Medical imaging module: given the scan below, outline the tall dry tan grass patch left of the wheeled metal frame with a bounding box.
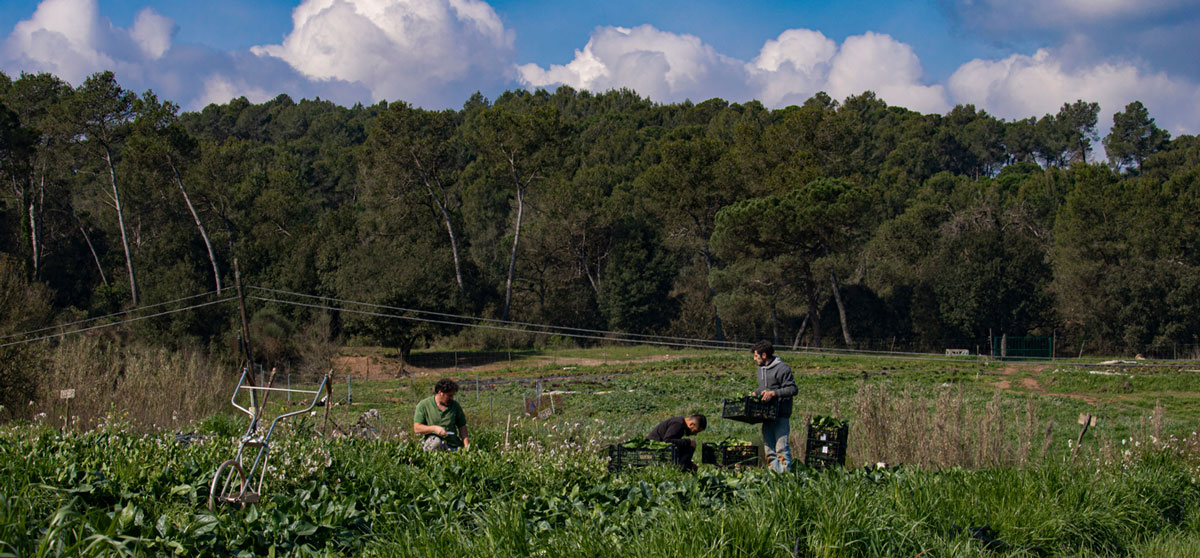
[35,337,236,428]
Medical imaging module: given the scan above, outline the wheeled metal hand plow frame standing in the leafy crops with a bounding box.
[209,367,331,511]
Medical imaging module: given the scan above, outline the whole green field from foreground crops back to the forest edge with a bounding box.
[0,348,1200,557]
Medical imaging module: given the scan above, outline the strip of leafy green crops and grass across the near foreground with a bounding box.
[0,417,1200,557]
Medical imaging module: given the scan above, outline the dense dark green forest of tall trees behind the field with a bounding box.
[0,72,1200,374]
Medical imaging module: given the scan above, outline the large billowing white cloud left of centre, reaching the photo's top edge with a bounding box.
[251,0,514,108]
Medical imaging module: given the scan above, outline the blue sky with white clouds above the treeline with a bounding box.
[0,0,1200,136]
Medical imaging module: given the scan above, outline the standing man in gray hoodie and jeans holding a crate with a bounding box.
[751,340,799,473]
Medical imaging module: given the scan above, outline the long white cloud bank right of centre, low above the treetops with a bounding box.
[518,25,949,112]
